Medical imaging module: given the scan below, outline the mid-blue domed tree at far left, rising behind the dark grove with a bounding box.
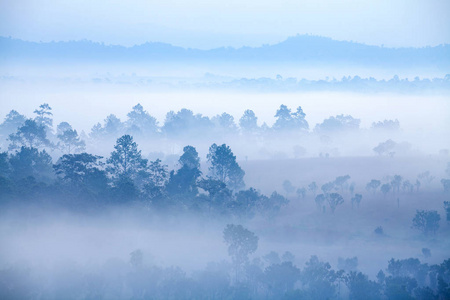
[9,119,52,150]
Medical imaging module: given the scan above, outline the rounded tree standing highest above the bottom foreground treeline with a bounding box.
[223,224,258,281]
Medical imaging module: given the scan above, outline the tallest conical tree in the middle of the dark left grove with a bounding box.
[107,134,147,180]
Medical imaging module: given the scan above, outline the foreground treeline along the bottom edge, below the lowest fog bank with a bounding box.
[0,224,450,300]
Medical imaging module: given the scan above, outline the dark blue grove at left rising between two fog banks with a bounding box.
[0,120,288,218]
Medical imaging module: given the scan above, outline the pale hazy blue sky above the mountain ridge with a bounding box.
[0,0,450,48]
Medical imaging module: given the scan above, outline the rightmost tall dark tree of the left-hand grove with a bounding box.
[207,144,245,190]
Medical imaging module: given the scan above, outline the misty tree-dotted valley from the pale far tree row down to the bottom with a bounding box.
[0,101,450,299]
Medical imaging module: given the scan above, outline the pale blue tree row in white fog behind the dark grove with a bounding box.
[0,104,400,146]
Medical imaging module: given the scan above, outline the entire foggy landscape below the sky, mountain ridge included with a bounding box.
[0,14,450,299]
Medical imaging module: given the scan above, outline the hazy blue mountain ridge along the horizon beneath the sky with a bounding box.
[0,35,450,68]
